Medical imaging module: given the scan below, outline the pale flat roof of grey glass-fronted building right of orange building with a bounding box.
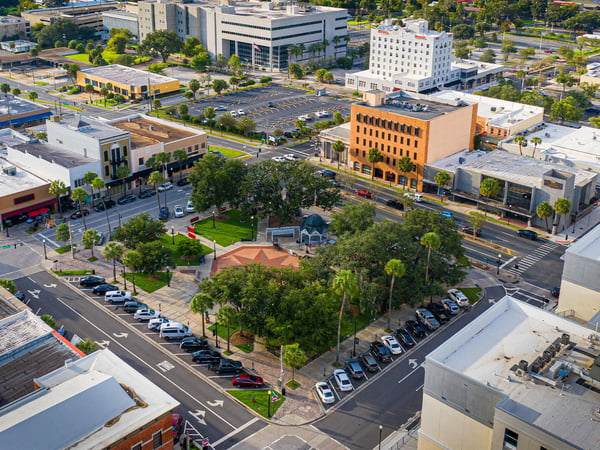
[461,150,596,186]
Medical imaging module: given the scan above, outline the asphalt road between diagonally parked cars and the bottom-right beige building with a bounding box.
[314,286,505,449]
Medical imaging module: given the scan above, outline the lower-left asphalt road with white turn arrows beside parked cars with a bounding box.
[15,271,265,448]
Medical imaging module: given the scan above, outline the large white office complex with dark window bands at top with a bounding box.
[138,0,348,71]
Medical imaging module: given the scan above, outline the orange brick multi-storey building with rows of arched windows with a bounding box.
[349,91,477,191]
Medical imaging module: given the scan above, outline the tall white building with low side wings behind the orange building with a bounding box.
[346,19,503,92]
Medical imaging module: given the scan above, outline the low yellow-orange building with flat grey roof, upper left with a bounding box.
[77,64,179,99]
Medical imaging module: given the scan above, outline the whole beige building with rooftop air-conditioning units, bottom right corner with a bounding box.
[418,296,600,450]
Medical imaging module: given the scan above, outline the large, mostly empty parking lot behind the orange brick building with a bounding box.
[189,85,350,132]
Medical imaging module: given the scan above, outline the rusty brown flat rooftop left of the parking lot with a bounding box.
[110,117,198,148]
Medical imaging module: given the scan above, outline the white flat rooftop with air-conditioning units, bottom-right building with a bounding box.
[425,296,600,449]
